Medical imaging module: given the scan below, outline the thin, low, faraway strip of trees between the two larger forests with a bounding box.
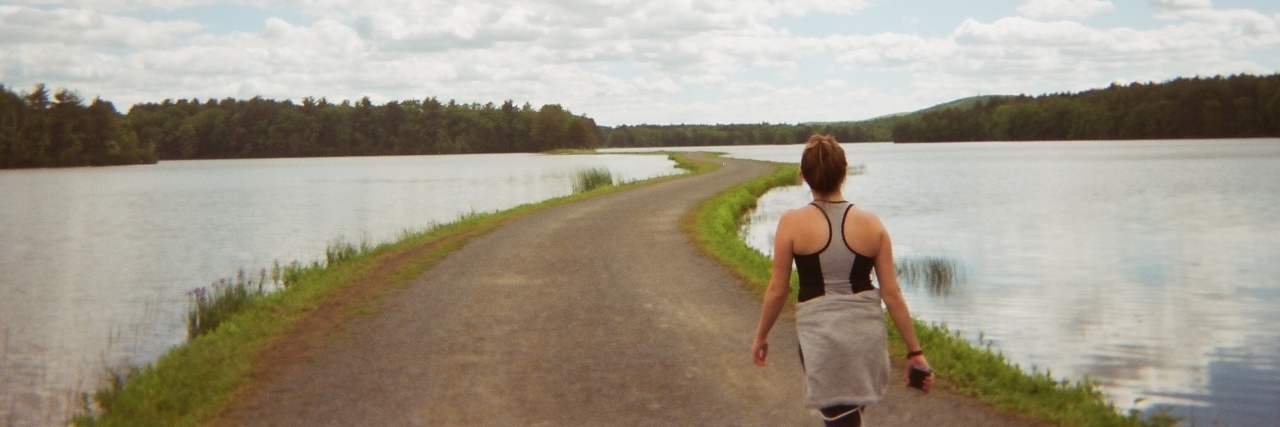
[602,121,876,147]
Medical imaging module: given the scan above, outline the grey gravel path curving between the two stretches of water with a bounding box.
[212,155,1025,427]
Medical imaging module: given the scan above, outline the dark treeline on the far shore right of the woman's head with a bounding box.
[892,74,1280,142]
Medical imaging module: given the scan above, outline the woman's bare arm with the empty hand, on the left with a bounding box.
[751,212,794,366]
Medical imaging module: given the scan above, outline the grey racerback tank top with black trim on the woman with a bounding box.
[795,201,876,302]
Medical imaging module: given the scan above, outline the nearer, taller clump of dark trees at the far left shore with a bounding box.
[0,84,156,169]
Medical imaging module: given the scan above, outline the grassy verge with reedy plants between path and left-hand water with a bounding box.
[73,153,708,426]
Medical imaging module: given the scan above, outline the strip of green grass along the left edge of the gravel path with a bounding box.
[70,153,705,426]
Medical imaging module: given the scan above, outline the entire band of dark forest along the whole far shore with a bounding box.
[0,74,1280,167]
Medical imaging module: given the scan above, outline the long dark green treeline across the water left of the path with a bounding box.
[0,84,600,167]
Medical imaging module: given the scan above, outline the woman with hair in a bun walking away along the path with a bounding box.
[751,136,933,427]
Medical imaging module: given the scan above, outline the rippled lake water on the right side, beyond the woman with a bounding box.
[660,139,1280,426]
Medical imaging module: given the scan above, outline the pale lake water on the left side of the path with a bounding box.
[0,155,678,426]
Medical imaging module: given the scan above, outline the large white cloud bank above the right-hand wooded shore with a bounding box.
[827,10,1280,112]
